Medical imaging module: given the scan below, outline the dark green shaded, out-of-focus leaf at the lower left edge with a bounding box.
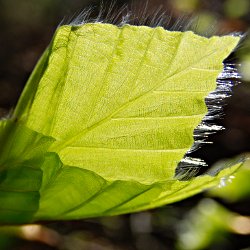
[0,121,54,224]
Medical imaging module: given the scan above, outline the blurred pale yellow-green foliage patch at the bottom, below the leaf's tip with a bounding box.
[177,199,235,250]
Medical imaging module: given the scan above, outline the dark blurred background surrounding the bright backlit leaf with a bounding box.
[0,0,250,250]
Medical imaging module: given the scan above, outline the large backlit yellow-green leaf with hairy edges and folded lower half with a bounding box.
[0,23,240,221]
